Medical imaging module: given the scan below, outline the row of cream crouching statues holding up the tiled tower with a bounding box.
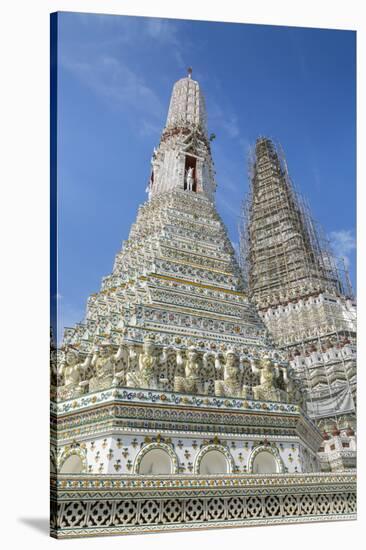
[57,336,301,408]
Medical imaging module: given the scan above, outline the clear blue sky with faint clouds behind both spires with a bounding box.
[58,13,356,342]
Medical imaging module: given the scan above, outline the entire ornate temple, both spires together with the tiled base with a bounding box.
[51,15,356,538]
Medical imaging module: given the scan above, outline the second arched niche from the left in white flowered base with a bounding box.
[134,443,178,475]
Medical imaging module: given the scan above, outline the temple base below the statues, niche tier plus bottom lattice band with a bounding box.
[51,388,356,538]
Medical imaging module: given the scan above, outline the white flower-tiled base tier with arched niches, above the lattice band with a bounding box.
[51,388,323,476]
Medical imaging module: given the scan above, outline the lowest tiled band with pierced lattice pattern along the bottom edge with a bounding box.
[51,473,356,538]
